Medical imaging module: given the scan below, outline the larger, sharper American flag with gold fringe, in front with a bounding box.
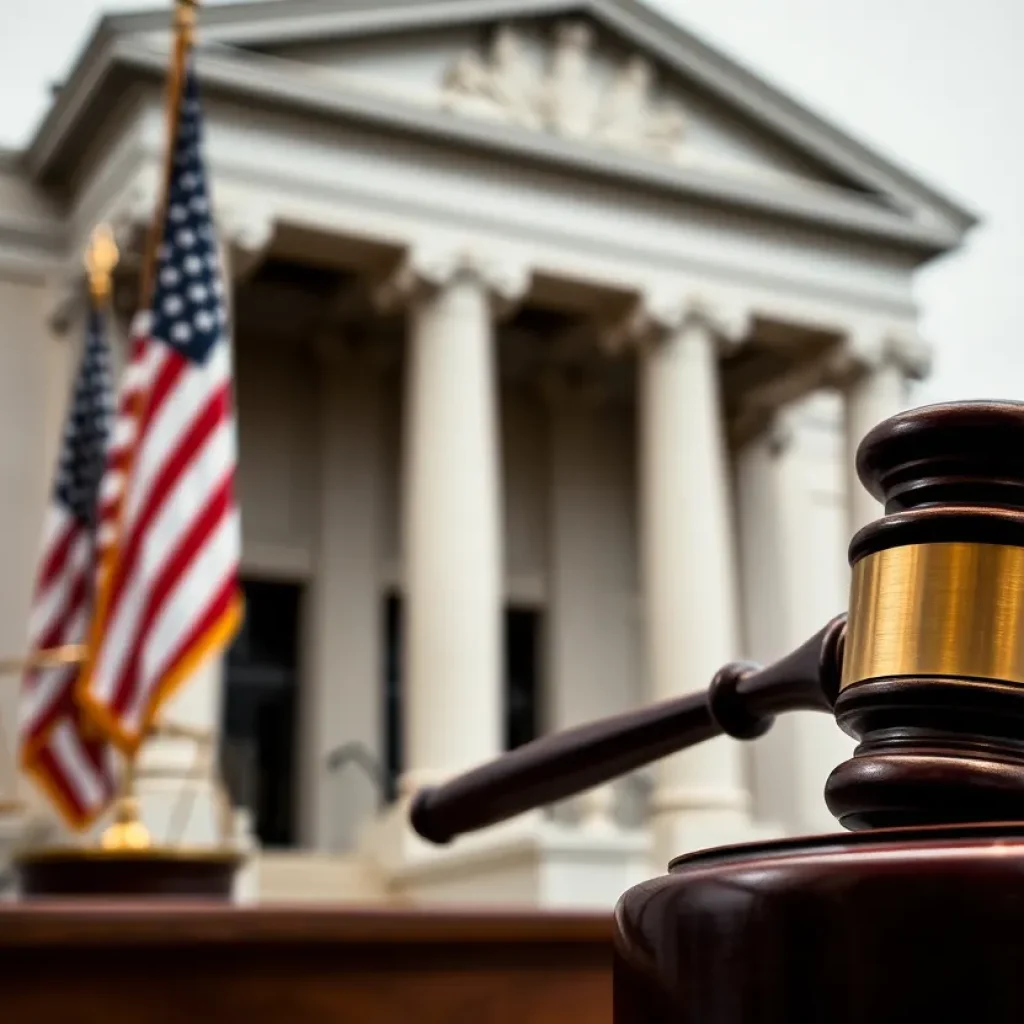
[79,62,242,752]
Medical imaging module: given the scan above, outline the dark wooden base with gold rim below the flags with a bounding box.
[13,847,244,901]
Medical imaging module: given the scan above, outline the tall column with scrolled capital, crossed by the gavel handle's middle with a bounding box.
[610,299,751,864]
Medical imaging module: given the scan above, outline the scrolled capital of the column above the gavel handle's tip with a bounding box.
[373,246,532,315]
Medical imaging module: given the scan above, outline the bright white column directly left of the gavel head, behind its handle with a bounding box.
[736,391,853,836]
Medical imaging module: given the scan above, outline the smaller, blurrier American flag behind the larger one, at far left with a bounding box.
[19,308,116,828]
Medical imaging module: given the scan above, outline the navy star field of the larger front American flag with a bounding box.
[150,62,227,364]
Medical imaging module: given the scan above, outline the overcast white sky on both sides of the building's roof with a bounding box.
[0,0,1024,400]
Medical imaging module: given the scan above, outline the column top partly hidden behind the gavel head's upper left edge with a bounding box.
[845,332,930,537]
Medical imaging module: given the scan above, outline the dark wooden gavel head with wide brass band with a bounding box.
[825,402,1024,829]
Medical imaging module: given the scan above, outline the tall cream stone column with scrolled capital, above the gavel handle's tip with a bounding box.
[378,252,527,793]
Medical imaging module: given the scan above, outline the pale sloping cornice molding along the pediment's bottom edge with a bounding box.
[27,32,962,257]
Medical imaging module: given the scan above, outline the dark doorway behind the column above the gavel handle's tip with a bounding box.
[383,594,544,801]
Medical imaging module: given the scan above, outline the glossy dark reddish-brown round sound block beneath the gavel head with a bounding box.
[614,823,1024,1024]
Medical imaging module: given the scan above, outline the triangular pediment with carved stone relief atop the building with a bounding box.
[30,0,975,252]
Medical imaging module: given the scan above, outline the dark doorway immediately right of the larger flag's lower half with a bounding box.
[220,581,301,847]
